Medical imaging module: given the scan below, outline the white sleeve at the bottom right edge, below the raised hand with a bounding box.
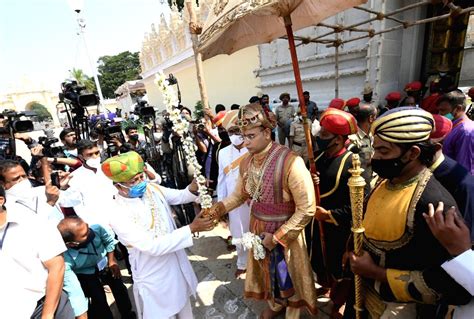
[441,249,474,319]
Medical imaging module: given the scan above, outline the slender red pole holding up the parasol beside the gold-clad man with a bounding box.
[283,15,329,283]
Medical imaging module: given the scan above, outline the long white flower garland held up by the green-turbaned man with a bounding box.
[155,72,212,209]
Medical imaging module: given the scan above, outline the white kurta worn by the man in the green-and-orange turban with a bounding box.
[110,184,197,319]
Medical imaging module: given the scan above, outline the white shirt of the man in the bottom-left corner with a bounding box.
[0,205,66,319]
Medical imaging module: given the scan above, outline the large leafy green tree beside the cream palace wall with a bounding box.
[98,51,140,98]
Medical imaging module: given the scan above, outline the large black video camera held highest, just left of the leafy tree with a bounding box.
[59,81,99,114]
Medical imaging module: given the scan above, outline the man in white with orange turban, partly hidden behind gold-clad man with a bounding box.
[217,110,250,278]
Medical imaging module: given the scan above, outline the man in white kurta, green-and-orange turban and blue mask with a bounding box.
[102,152,212,319]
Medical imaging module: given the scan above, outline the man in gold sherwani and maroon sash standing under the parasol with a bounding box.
[209,104,317,318]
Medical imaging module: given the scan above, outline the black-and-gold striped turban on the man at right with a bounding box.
[371,107,434,144]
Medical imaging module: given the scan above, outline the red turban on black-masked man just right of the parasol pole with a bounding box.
[320,108,358,135]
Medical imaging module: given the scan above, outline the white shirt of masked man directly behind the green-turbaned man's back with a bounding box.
[68,166,117,229]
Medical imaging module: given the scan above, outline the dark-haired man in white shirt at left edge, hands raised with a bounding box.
[0,160,71,224]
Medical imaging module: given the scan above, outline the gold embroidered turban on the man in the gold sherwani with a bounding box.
[237,103,276,130]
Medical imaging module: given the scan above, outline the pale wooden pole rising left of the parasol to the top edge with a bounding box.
[185,0,209,114]
